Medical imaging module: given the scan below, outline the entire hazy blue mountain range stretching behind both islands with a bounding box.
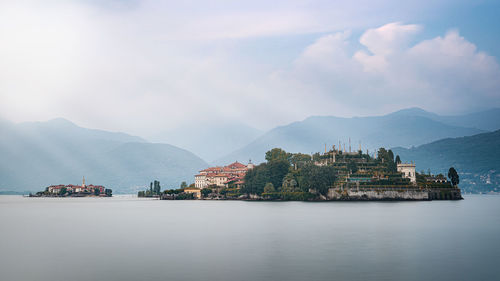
[0,108,500,192]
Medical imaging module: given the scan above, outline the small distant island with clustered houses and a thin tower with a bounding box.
[29,177,113,197]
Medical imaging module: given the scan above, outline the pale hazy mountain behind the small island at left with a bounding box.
[0,119,208,192]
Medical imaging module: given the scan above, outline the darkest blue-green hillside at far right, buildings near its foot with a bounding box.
[392,130,500,192]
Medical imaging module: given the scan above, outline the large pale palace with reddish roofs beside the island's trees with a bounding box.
[194,161,254,189]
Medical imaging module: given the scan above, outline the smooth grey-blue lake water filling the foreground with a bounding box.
[0,196,500,281]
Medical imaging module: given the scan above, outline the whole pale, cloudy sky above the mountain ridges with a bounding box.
[0,0,500,136]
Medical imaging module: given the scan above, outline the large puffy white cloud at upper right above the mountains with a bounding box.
[272,22,500,114]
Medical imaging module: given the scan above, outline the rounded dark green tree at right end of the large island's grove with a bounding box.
[299,164,336,195]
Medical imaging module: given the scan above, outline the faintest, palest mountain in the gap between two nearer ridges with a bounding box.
[149,120,262,162]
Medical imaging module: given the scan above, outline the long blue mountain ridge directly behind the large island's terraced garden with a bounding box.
[216,109,484,163]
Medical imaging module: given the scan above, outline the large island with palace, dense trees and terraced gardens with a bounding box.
[157,144,463,201]
